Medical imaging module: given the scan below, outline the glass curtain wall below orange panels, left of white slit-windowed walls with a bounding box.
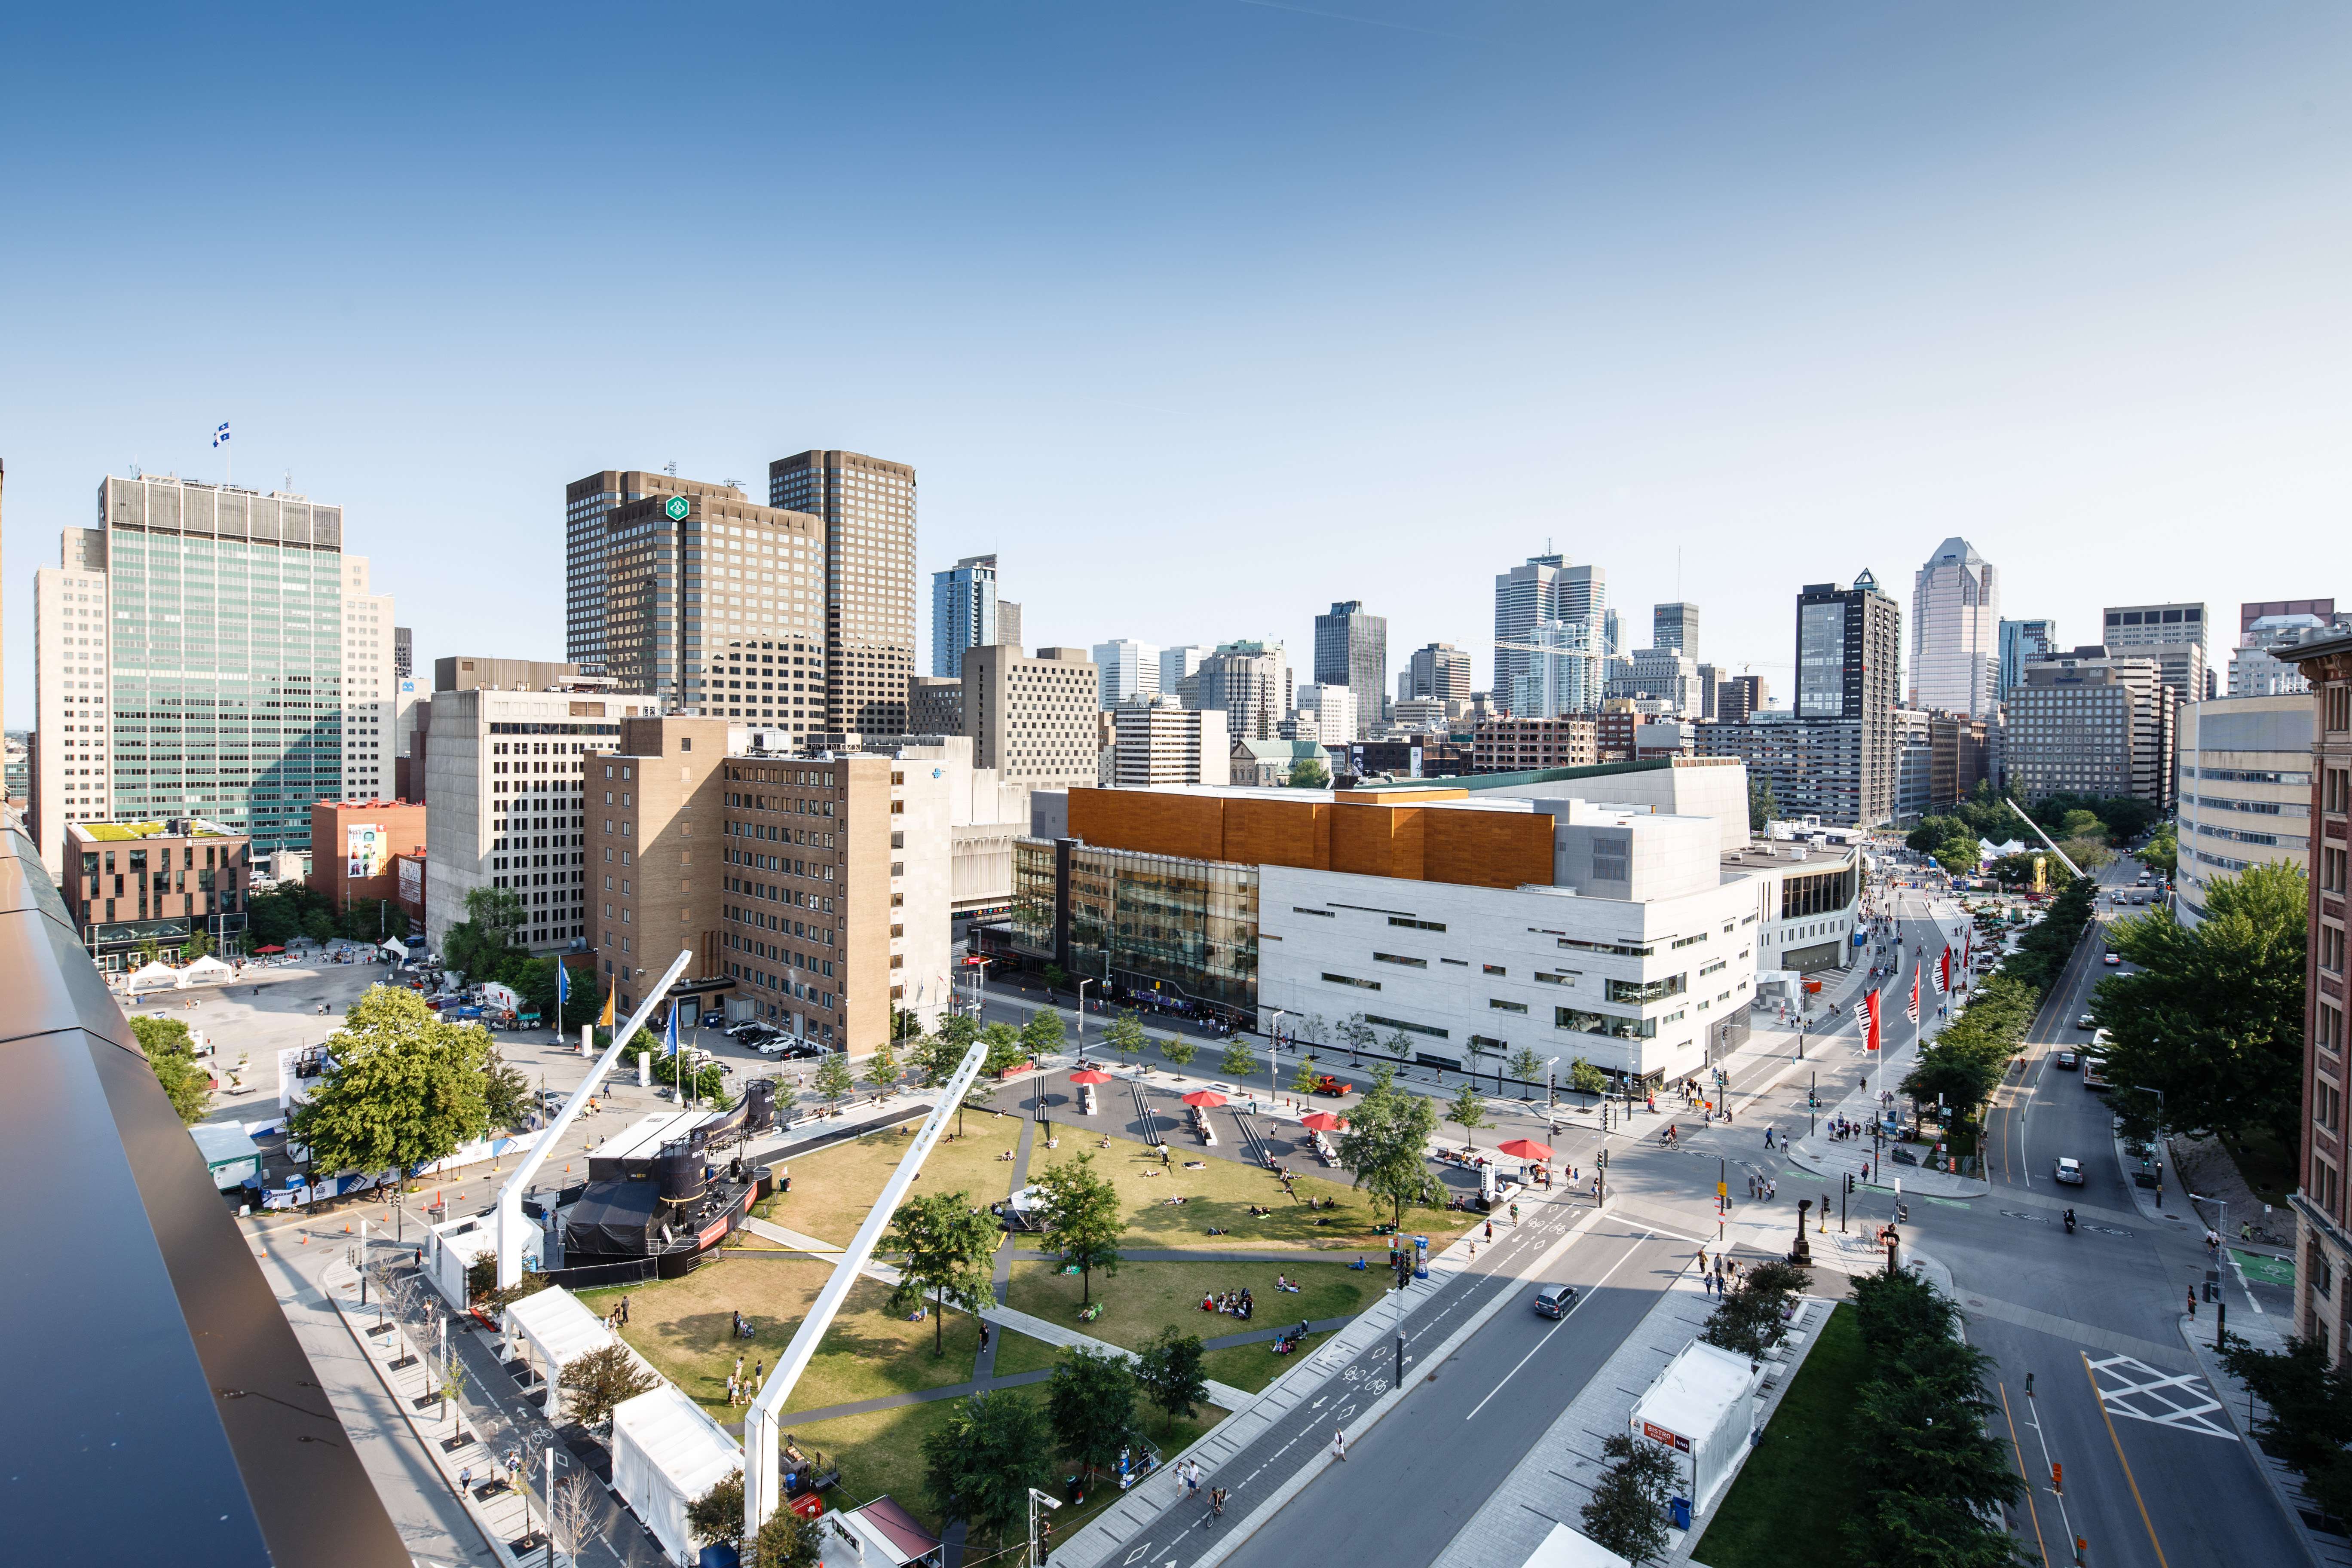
[1014,839,1259,1016]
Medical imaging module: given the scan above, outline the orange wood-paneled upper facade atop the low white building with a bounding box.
[1070,790,1553,888]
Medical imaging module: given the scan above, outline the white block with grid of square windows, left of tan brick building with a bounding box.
[426,686,661,952]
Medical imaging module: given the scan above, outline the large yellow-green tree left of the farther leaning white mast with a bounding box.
[287,985,489,1173]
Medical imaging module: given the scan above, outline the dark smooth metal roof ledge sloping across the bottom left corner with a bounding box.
[0,827,409,1568]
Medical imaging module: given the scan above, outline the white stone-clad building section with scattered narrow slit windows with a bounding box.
[1259,804,1759,1084]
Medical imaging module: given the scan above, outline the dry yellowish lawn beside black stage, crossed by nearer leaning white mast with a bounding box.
[581,1253,981,1422]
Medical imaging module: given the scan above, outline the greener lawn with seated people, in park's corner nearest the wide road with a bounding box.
[997,1262,1387,1363]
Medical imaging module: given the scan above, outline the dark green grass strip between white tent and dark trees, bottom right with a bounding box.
[1691,1305,1868,1568]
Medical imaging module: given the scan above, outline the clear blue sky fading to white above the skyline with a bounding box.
[0,0,2352,729]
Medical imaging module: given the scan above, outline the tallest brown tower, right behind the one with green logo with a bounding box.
[767,451,917,736]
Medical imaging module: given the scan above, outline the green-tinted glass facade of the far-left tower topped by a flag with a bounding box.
[99,480,343,856]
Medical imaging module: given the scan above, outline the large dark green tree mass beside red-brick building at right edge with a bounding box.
[2091,865,2307,1147]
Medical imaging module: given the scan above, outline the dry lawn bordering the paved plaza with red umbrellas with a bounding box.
[1030,1128,1479,1250]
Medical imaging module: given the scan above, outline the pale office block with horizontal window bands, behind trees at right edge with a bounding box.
[2176,691,2305,926]
